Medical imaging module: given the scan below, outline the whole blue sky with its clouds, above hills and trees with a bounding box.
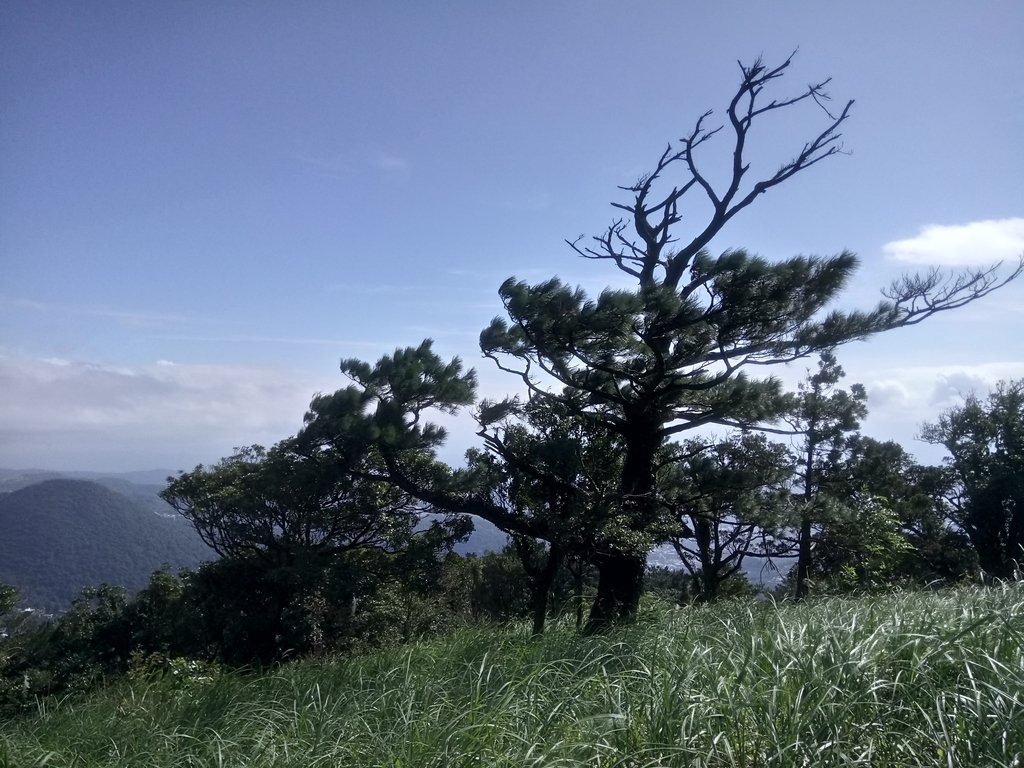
[0,0,1024,471]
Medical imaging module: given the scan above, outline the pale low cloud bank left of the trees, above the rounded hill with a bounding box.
[0,357,344,471]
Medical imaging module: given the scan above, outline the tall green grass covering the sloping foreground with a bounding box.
[0,585,1024,768]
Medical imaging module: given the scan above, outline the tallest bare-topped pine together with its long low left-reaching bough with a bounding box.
[305,56,1024,630]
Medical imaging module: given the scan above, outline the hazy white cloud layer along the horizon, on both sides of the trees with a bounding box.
[0,356,1024,471]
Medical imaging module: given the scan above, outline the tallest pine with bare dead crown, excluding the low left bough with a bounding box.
[480,56,1024,629]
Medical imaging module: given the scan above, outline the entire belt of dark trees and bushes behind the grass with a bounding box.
[0,54,1024,720]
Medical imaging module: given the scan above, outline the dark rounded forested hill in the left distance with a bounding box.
[0,475,216,612]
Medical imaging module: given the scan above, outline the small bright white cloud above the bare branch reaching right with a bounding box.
[882,218,1024,266]
